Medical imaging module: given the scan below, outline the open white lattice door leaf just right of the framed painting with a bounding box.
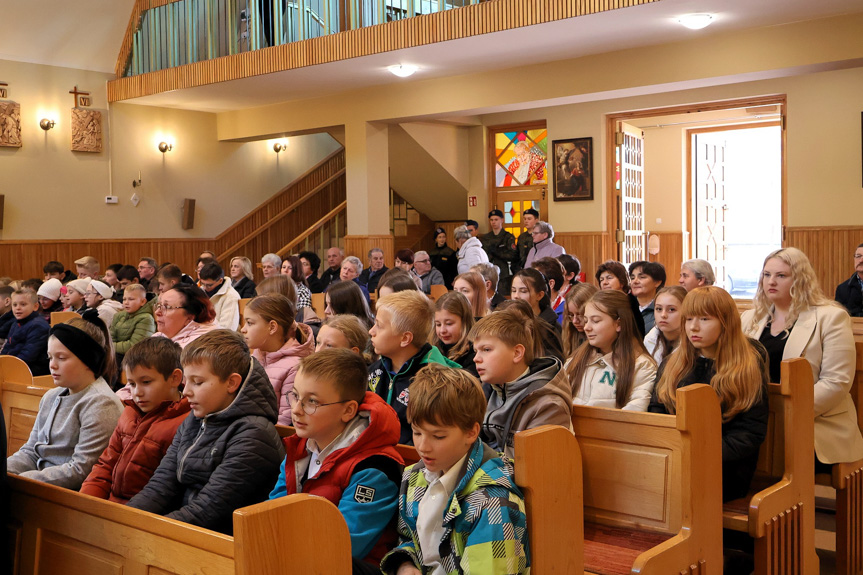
[615,122,647,266]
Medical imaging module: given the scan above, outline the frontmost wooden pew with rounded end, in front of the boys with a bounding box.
[9,475,351,575]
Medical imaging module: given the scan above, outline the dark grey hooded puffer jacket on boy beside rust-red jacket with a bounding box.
[128,358,285,534]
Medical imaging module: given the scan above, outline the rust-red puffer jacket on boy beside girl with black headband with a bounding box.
[81,398,189,503]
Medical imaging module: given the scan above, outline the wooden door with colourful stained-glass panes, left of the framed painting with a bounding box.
[489,122,548,226]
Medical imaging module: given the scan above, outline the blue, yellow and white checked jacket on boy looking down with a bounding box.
[381,440,530,575]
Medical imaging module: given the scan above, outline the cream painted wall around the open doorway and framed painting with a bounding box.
[483,68,863,236]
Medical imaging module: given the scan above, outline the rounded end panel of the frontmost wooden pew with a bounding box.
[234,493,351,575]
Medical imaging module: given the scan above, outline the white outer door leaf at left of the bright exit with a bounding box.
[693,133,728,287]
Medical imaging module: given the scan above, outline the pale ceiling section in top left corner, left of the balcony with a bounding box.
[0,0,135,73]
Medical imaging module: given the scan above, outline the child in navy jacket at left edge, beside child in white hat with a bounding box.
[2,289,51,379]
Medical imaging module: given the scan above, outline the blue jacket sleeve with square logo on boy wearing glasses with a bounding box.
[339,469,399,559]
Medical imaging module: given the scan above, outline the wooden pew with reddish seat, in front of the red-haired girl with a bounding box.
[572,385,722,575]
